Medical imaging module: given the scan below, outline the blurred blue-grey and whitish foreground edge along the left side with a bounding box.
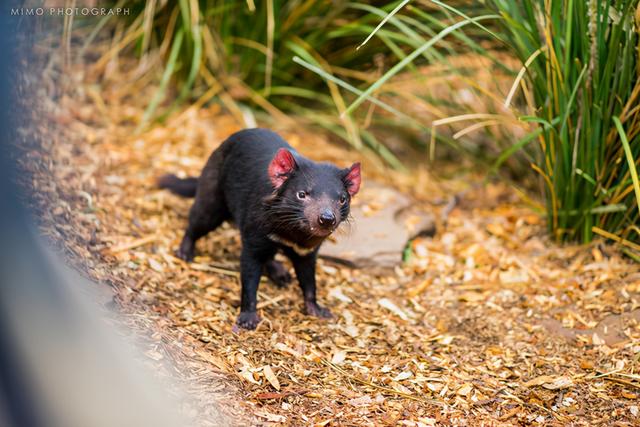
[0,1,194,427]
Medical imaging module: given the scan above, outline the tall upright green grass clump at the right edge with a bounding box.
[490,0,640,247]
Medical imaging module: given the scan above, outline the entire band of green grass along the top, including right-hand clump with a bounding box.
[83,0,640,250]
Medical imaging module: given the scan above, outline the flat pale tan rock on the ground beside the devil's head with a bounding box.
[320,183,435,268]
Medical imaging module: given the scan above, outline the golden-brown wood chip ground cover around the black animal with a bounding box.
[13,49,640,426]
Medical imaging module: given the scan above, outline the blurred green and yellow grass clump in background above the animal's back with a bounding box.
[83,0,438,169]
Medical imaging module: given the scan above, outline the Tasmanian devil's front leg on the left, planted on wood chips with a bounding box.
[236,245,262,329]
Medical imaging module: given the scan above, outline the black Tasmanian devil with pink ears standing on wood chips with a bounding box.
[158,129,360,329]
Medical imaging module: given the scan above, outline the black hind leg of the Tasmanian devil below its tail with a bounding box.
[176,150,229,261]
